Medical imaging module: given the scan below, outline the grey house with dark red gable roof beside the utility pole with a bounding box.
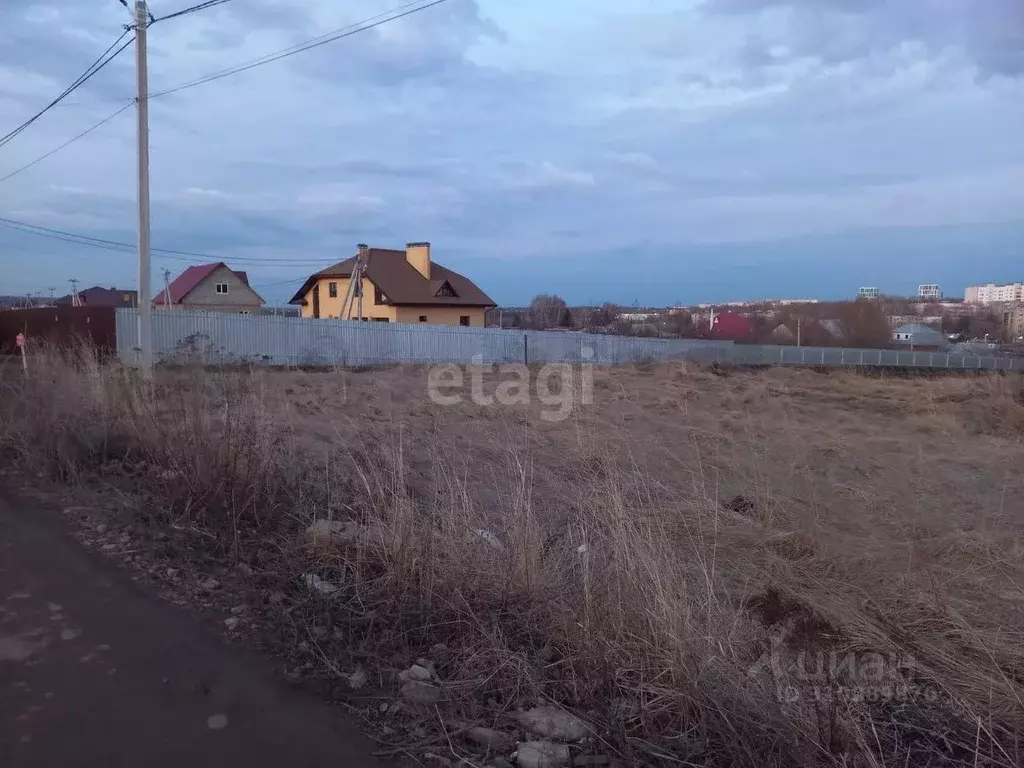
[153,261,265,314]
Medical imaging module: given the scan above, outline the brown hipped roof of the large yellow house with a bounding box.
[289,248,498,306]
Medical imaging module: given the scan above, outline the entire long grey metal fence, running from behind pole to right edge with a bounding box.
[117,309,1024,371]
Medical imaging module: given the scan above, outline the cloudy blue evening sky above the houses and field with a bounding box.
[0,0,1024,305]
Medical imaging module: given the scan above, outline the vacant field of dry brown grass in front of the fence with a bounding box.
[0,358,1024,766]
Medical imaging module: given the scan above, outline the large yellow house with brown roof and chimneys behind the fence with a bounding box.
[289,243,497,328]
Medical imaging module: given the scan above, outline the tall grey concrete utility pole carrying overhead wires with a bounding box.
[135,0,153,376]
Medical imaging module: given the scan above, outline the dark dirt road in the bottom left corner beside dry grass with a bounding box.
[0,492,382,768]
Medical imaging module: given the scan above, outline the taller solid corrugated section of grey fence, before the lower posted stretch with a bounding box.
[117,309,729,367]
